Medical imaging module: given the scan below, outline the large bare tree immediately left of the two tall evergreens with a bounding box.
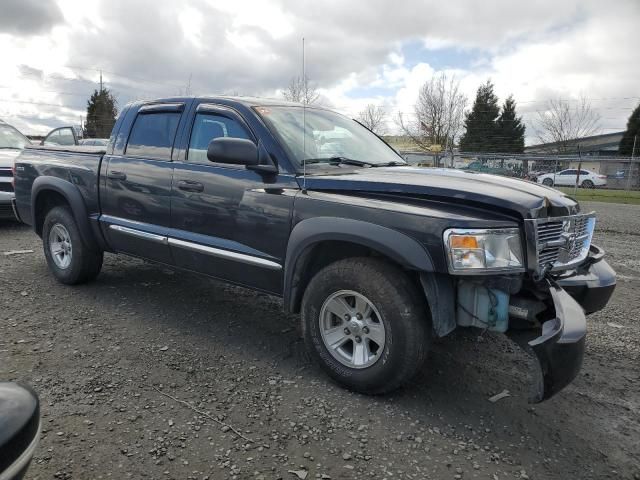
[398,72,467,161]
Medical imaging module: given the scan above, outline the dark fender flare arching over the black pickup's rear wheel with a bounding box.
[31,176,100,250]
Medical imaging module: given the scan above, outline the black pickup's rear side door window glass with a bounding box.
[125,112,180,160]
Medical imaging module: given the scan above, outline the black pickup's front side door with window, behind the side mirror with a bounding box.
[169,105,297,293]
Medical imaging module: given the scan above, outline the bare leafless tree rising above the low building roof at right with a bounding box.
[535,97,600,152]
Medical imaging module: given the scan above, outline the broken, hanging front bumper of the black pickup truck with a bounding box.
[509,246,616,403]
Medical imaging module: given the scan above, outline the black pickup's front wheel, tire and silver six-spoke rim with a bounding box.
[302,258,431,394]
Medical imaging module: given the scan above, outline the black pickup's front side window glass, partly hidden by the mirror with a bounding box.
[187,113,251,163]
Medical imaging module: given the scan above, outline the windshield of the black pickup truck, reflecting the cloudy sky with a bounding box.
[256,106,406,167]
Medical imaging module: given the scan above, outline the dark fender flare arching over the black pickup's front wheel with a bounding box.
[283,217,434,312]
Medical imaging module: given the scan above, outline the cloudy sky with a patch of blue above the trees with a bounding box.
[0,0,640,143]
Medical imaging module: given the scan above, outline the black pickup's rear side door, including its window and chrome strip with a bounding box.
[100,103,184,263]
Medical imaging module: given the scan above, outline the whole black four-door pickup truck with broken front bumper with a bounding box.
[15,97,616,401]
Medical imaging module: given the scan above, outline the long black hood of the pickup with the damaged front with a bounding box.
[306,167,580,218]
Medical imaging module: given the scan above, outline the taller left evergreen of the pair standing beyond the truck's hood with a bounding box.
[460,80,500,152]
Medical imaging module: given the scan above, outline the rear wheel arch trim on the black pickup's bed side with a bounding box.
[31,176,100,250]
